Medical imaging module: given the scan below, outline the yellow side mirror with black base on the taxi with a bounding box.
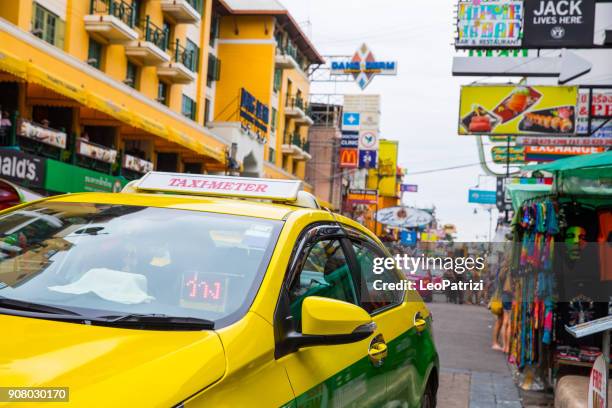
[287,296,376,349]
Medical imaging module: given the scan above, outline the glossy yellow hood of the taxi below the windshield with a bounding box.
[0,315,225,407]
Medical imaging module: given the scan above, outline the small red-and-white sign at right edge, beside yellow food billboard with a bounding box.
[576,89,612,138]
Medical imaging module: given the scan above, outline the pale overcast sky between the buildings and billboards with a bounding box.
[281,0,504,241]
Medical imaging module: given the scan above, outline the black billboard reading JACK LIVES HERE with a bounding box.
[523,0,595,48]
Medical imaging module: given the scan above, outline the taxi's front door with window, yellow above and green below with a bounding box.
[274,225,387,407]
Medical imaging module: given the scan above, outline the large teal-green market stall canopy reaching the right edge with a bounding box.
[522,152,612,196]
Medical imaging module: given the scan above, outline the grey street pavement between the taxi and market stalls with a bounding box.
[427,299,522,408]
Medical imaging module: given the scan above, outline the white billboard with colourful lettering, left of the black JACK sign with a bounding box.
[455,0,523,48]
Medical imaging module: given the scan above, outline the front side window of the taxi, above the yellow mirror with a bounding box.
[289,240,357,327]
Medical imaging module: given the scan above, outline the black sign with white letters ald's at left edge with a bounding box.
[0,149,46,187]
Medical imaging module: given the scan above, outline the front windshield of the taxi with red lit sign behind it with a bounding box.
[0,201,282,327]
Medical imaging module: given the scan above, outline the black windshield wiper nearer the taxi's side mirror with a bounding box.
[92,313,215,330]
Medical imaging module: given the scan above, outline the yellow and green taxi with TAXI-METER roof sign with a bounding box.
[0,172,438,408]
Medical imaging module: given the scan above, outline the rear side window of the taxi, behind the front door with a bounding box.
[353,242,403,314]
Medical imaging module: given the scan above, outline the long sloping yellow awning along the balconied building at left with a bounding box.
[0,28,227,163]
